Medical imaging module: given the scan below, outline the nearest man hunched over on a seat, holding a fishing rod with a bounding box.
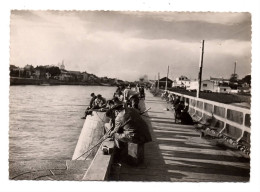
[107,105,152,164]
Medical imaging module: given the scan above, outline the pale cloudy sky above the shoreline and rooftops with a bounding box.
[10,11,251,81]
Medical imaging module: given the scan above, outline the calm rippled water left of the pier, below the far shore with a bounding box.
[9,86,115,160]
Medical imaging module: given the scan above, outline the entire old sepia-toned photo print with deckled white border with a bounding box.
[3,1,259,192]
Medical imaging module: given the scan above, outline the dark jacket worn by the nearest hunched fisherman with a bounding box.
[114,108,152,143]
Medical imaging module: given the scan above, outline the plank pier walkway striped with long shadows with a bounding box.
[110,92,250,182]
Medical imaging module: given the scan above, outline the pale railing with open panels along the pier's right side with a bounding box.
[170,92,251,144]
